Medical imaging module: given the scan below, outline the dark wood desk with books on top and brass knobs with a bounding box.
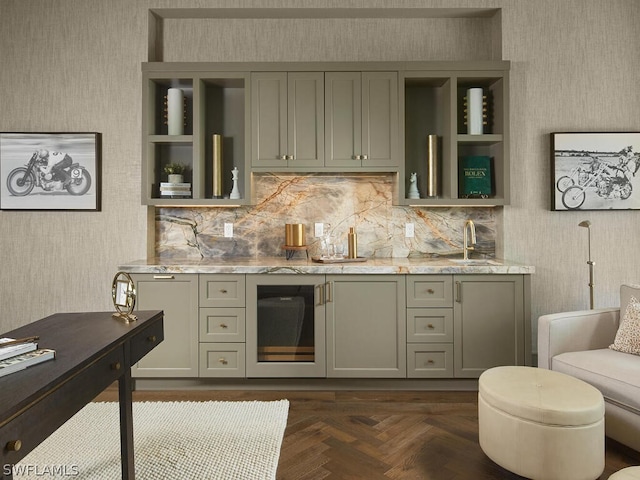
[0,311,164,480]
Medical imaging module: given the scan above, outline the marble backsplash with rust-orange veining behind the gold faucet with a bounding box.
[155,174,496,258]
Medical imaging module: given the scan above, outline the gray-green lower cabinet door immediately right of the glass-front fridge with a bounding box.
[326,275,406,378]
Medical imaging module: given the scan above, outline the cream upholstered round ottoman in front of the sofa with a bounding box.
[478,367,604,480]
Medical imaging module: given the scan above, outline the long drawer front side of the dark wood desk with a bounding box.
[0,345,129,464]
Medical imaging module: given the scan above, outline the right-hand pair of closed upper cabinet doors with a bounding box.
[325,72,399,168]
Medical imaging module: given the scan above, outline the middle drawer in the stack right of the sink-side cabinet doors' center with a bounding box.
[407,308,453,343]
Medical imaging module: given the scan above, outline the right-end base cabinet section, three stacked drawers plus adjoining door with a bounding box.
[406,274,531,378]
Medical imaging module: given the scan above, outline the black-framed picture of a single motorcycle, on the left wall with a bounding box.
[0,132,102,211]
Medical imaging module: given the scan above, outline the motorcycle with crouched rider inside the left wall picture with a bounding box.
[7,152,91,197]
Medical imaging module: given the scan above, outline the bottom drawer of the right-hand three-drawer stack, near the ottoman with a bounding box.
[407,343,453,378]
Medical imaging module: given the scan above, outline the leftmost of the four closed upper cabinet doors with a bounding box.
[251,72,287,167]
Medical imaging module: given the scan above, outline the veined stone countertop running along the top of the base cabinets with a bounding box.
[118,252,535,275]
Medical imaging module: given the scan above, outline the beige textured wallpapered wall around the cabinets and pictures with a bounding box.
[0,0,640,352]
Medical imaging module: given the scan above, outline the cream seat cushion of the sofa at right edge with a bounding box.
[551,348,640,415]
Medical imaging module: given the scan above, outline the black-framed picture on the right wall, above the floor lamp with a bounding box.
[551,132,640,211]
